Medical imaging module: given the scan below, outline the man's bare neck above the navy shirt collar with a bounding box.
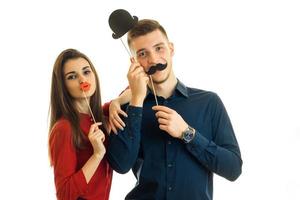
[151,73,177,99]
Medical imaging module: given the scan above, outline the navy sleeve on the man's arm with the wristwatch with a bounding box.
[186,94,242,181]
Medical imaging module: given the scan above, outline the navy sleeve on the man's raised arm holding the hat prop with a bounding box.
[106,106,143,174]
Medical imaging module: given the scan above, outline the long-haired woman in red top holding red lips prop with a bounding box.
[49,49,115,200]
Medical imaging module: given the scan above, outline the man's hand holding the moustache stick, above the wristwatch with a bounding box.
[152,106,188,138]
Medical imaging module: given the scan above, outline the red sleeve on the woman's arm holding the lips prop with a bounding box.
[50,122,87,200]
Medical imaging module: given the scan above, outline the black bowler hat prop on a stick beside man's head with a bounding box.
[108,9,138,39]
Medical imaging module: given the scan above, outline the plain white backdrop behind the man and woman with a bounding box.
[0,0,300,200]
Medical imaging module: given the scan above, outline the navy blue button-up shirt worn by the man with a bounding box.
[107,81,242,200]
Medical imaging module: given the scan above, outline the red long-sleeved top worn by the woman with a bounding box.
[49,111,112,200]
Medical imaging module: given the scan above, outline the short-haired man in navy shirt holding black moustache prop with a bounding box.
[107,20,242,200]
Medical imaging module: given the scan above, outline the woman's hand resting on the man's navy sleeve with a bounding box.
[109,98,127,134]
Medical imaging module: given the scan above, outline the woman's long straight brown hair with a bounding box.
[49,49,106,163]
